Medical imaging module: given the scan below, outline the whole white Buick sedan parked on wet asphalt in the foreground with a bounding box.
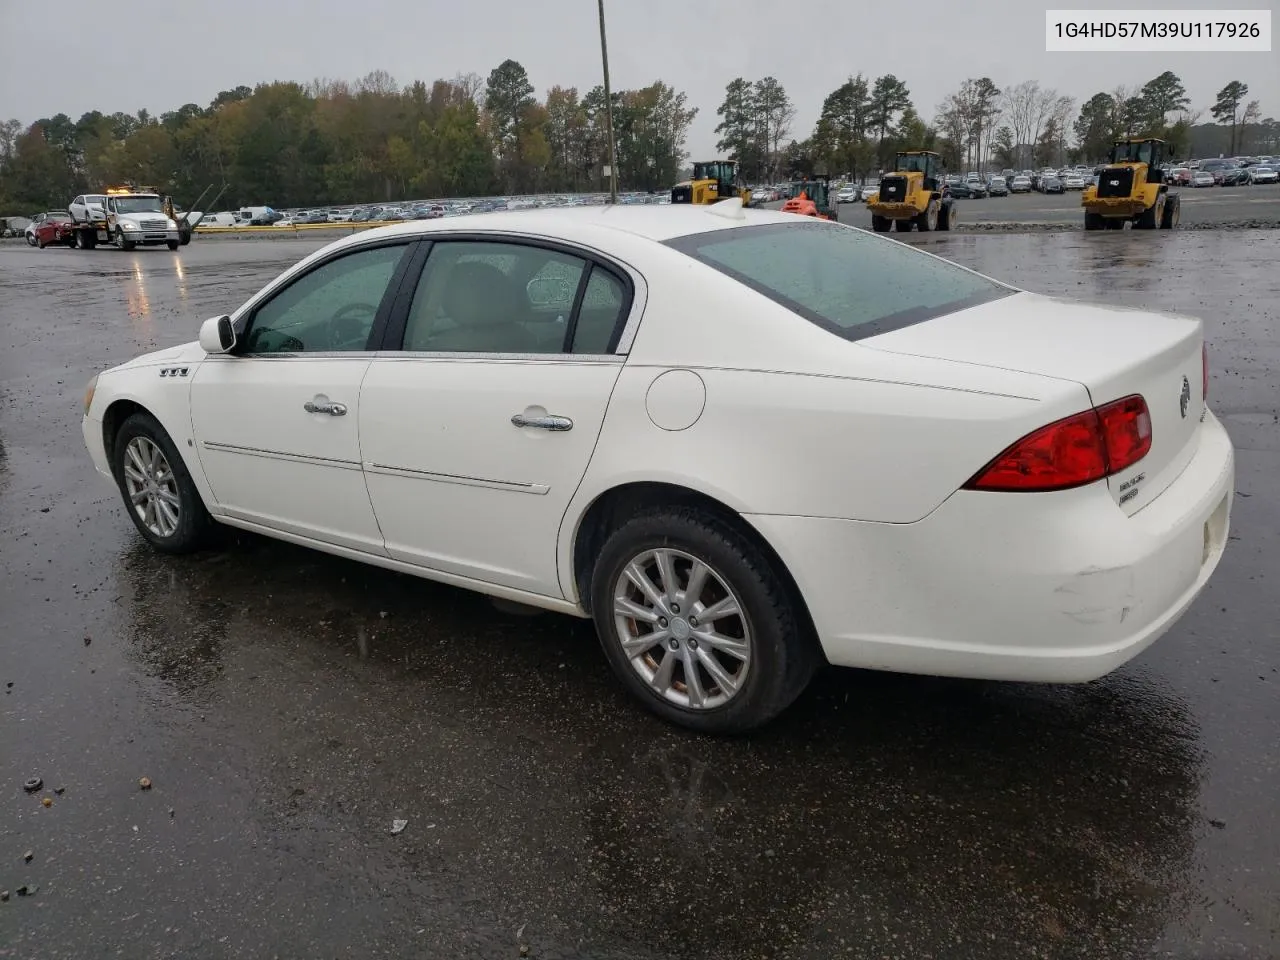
[83,200,1234,732]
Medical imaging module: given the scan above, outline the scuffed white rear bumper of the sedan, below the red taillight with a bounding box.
[748,413,1235,682]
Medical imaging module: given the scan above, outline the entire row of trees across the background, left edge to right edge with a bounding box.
[0,60,1280,215]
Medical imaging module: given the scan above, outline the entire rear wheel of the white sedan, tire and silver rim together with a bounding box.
[591,507,820,733]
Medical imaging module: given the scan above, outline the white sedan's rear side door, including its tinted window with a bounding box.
[360,239,630,598]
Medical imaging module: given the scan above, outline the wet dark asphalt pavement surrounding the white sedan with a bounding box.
[0,232,1280,960]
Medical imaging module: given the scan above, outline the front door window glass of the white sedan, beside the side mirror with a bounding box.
[244,244,408,353]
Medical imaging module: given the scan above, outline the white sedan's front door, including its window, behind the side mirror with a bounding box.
[191,242,412,554]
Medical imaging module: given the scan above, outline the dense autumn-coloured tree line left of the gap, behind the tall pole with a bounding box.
[0,60,696,215]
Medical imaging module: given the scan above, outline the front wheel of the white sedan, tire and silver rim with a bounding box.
[111,413,214,553]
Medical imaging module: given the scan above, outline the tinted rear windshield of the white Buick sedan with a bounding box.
[667,218,1016,340]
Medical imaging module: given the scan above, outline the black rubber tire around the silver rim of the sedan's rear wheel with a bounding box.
[590,507,822,733]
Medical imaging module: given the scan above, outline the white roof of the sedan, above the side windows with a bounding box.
[320,204,796,253]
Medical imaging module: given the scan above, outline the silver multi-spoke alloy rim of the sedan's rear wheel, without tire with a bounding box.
[613,548,751,710]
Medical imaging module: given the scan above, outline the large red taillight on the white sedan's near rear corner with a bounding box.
[964,394,1151,493]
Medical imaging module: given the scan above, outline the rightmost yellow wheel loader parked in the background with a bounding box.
[1080,137,1183,230]
